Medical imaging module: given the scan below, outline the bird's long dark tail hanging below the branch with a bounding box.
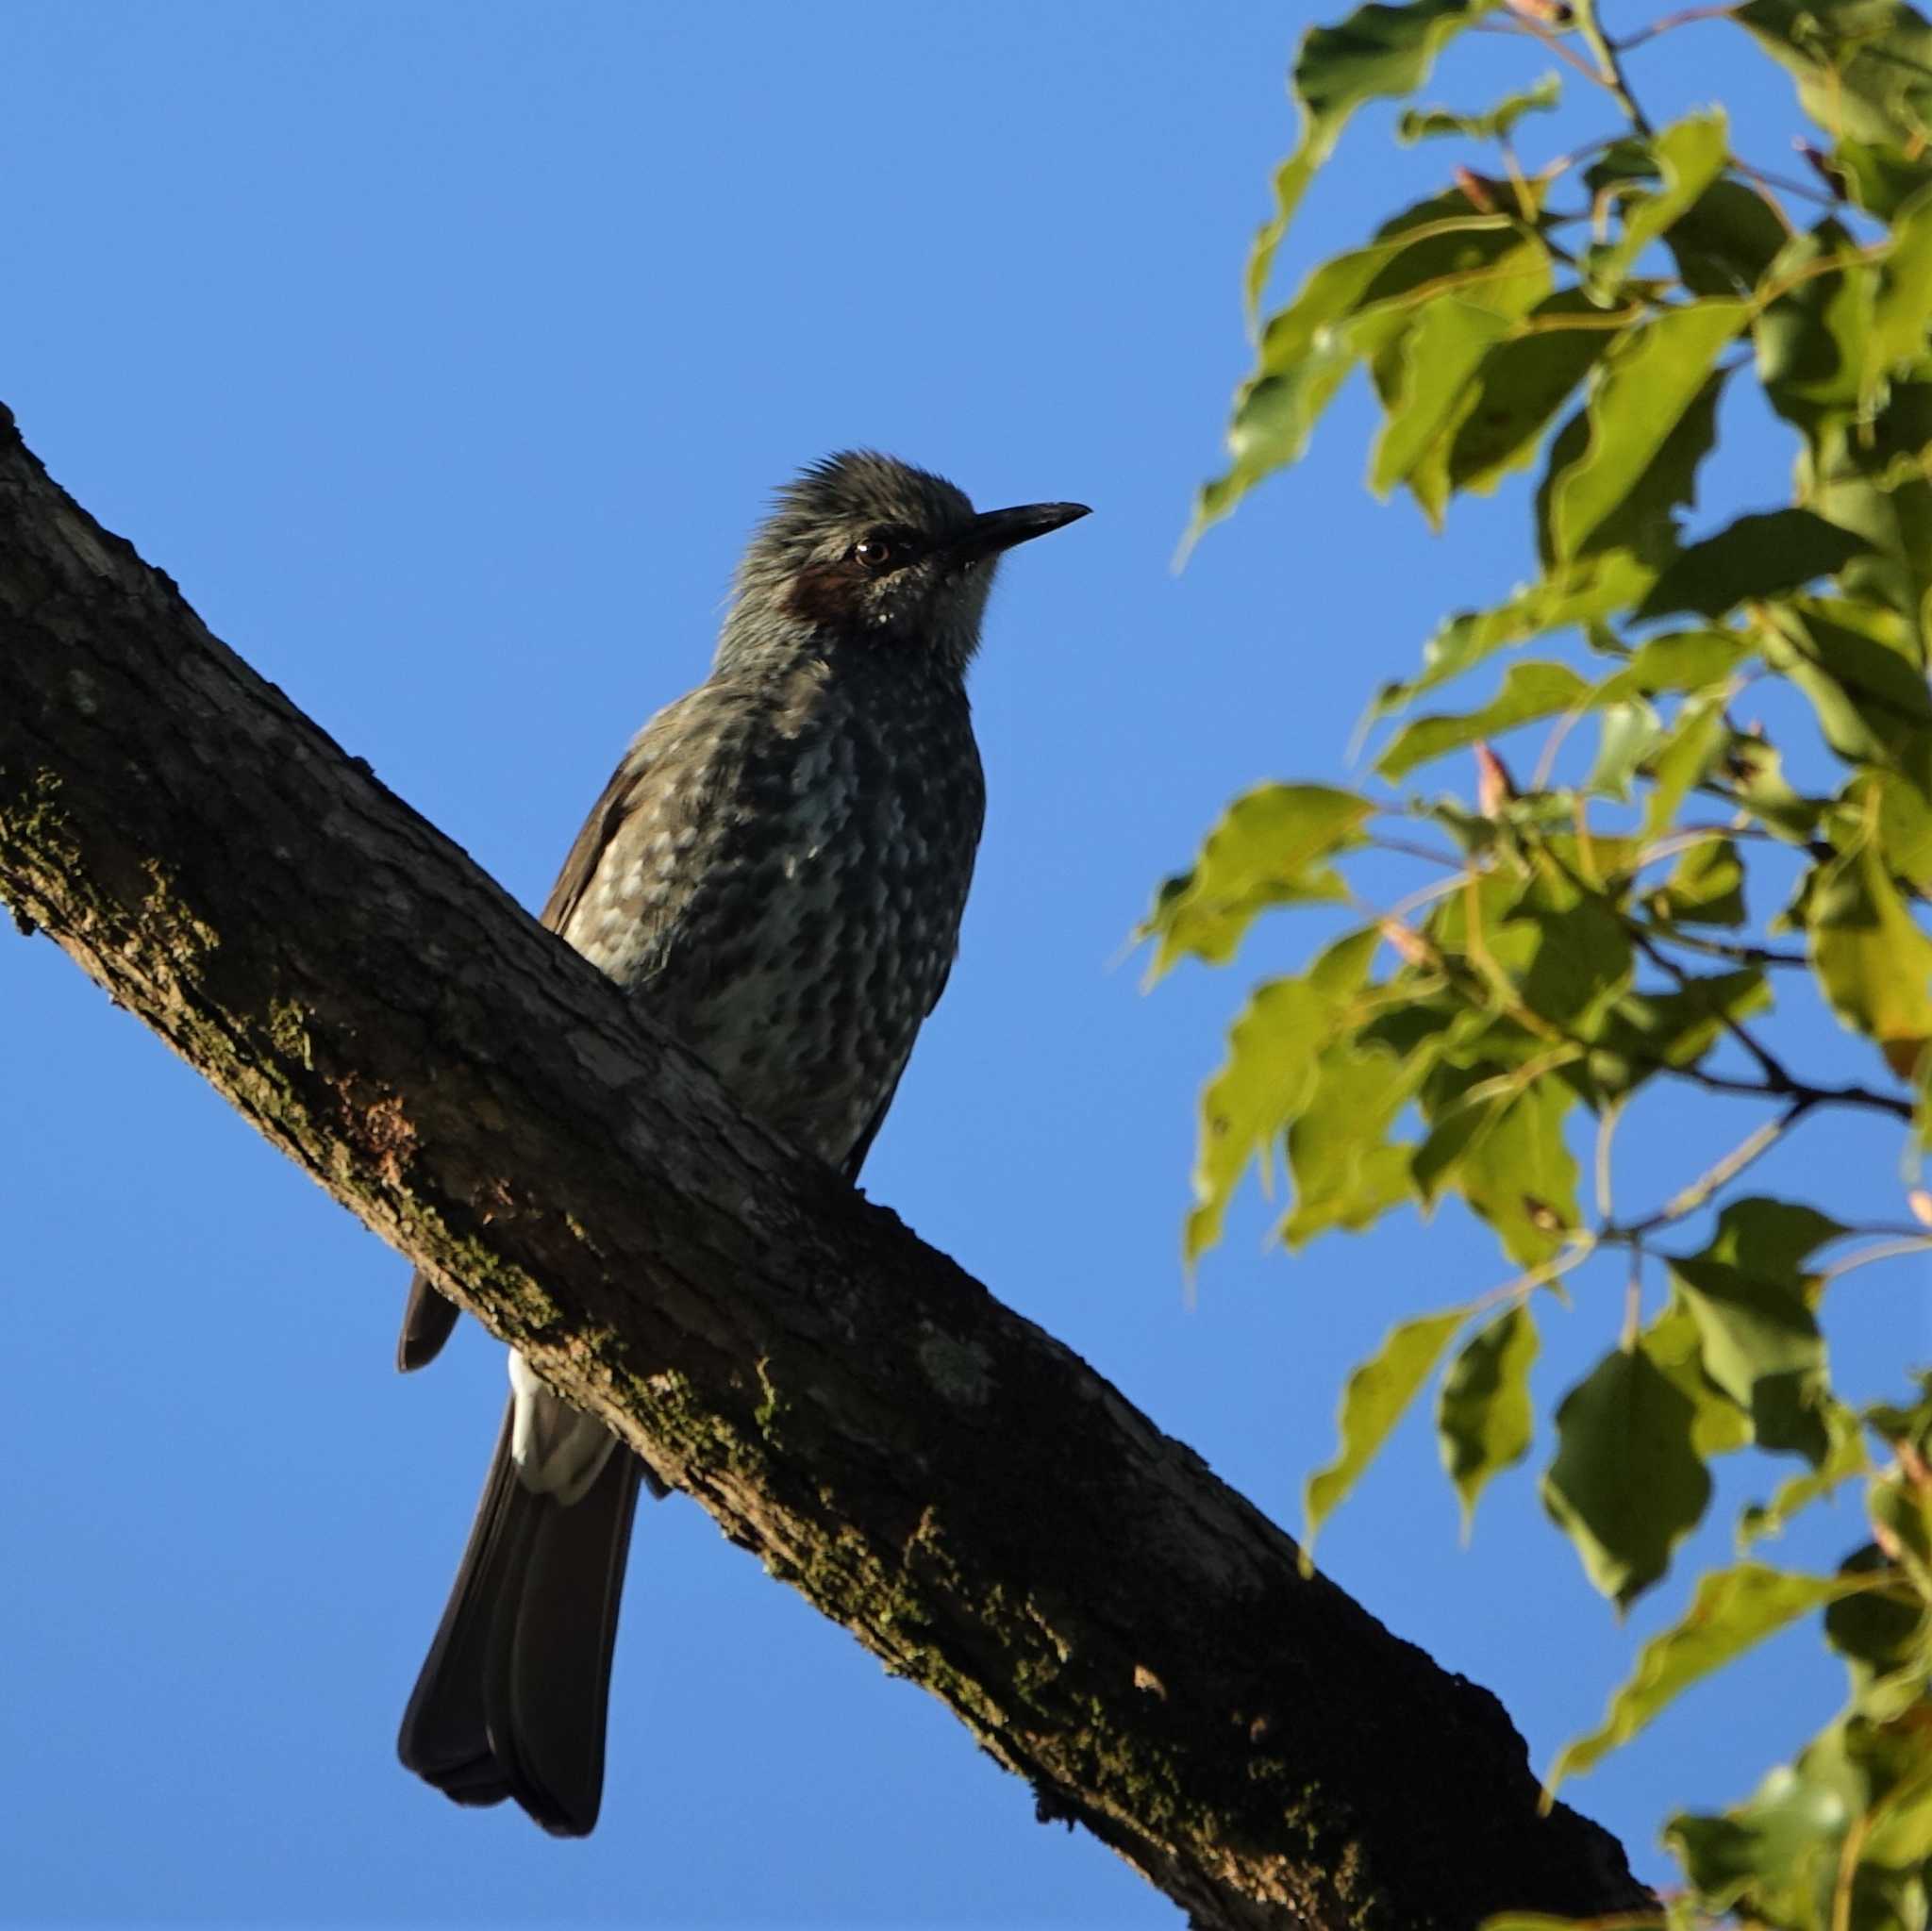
[396,1400,643,1837]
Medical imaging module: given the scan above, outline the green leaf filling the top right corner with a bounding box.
[1733,0,1932,147]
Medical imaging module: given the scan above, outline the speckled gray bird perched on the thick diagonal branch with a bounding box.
[396,450,1088,1837]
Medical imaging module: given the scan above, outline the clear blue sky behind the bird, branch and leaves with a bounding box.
[0,0,1926,1925]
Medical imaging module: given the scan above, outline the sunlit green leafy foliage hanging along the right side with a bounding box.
[1141,0,1932,1931]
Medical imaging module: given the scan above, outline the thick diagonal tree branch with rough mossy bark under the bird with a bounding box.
[0,408,1652,1927]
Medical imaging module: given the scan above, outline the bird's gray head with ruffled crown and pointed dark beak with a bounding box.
[719,450,1088,672]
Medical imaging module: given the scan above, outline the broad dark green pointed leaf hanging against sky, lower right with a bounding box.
[1543,1342,1709,1608]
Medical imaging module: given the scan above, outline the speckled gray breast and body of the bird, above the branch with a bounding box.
[545,653,985,1166]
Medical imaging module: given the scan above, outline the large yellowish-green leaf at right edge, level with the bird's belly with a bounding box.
[1807,814,1932,1079]
